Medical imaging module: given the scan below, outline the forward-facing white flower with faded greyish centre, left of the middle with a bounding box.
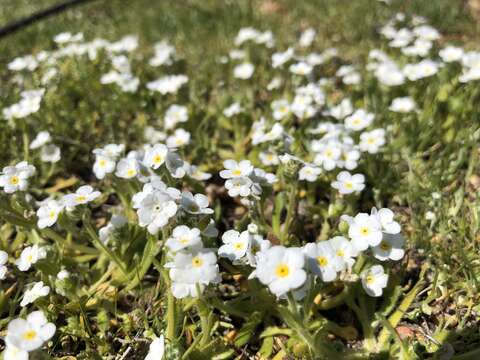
[137,190,178,235]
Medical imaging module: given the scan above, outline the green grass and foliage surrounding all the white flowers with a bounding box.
[0,0,480,359]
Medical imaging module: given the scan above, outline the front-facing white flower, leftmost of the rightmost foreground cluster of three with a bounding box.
[348,213,382,251]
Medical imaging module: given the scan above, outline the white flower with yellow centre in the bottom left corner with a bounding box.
[5,311,56,351]
